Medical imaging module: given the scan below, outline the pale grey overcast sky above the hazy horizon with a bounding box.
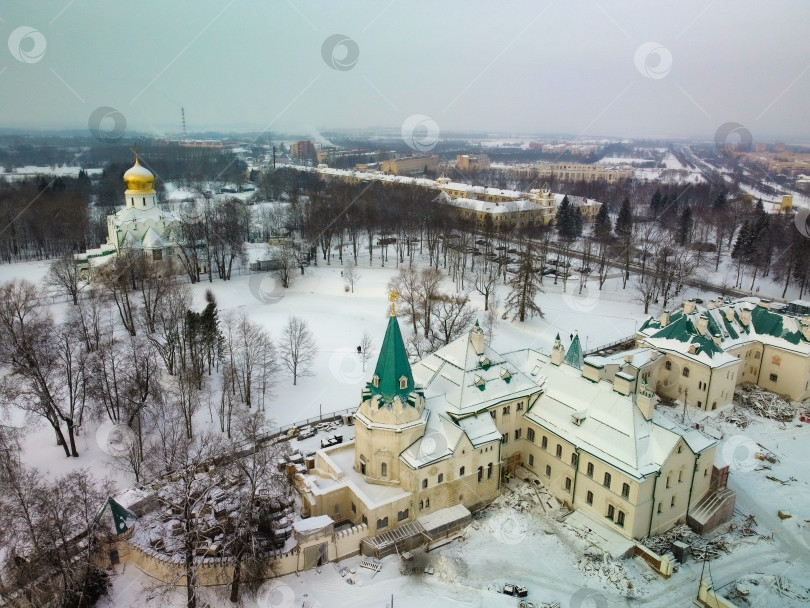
[0,0,810,142]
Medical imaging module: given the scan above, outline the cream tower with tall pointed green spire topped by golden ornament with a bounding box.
[355,292,427,484]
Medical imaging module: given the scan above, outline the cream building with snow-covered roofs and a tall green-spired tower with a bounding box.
[295,296,734,545]
